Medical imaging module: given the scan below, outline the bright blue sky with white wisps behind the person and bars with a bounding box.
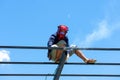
[0,0,120,80]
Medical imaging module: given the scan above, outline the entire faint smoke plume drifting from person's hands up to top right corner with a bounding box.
[74,0,120,47]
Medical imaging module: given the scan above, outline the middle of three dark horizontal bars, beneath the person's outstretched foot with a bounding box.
[0,62,120,66]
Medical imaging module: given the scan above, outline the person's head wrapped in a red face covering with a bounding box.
[57,25,68,40]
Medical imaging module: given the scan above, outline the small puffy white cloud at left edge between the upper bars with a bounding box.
[0,50,10,62]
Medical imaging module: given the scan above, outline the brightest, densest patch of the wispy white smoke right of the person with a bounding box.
[82,20,111,46]
